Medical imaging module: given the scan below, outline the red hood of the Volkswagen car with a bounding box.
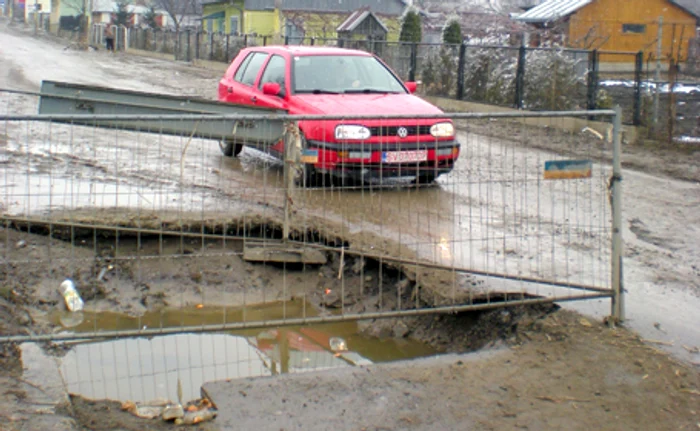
[294,94,442,115]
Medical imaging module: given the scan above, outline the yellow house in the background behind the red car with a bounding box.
[202,0,406,40]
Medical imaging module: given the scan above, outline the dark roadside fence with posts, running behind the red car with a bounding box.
[74,26,700,136]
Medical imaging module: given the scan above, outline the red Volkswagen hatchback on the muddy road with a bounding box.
[219,46,459,183]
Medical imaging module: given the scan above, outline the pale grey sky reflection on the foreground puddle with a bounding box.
[61,334,271,401]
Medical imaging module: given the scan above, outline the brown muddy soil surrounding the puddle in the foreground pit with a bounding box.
[0,224,700,430]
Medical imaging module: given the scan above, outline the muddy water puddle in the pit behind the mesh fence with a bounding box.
[50,301,437,402]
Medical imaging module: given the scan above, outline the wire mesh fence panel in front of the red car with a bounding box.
[0,87,621,400]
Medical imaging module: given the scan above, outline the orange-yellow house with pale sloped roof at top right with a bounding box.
[515,0,700,62]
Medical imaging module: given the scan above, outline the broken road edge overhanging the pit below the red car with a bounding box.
[0,207,486,306]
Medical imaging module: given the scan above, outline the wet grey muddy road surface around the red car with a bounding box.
[0,22,700,359]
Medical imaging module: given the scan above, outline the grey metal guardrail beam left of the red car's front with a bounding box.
[34,81,285,146]
